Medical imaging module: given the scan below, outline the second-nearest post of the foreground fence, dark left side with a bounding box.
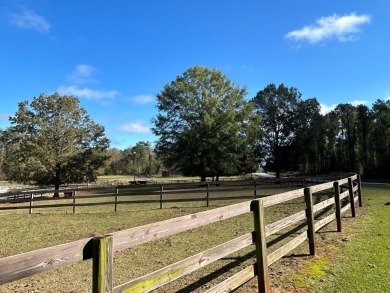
[251,199,271,293]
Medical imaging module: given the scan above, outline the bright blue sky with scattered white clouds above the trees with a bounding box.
[0,0,390,149]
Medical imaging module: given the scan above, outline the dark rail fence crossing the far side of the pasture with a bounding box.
[0,177,348,214]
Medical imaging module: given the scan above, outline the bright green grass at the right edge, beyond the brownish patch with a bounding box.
[310,186,390,292]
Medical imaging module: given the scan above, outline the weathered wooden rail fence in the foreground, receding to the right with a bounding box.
[0,175,362,292]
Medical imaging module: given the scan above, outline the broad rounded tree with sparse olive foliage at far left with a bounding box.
[1,93,109,196]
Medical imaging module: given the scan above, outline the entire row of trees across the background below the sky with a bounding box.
[0,66,390,188]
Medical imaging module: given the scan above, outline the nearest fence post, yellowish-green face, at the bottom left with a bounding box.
[92,235,114,293]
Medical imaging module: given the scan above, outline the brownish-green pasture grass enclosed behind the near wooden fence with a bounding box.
[0,175,384,292]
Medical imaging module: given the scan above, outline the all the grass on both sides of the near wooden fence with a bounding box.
[0,182,390,293]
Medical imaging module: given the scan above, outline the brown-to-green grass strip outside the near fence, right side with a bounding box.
[271,185,390,293]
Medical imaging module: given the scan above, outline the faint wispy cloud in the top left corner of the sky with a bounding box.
[10,10,51,33]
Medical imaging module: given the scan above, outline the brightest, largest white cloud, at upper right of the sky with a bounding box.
[285,13,371,44]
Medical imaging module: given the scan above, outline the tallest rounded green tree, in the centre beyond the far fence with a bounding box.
[153,66,259,180]
